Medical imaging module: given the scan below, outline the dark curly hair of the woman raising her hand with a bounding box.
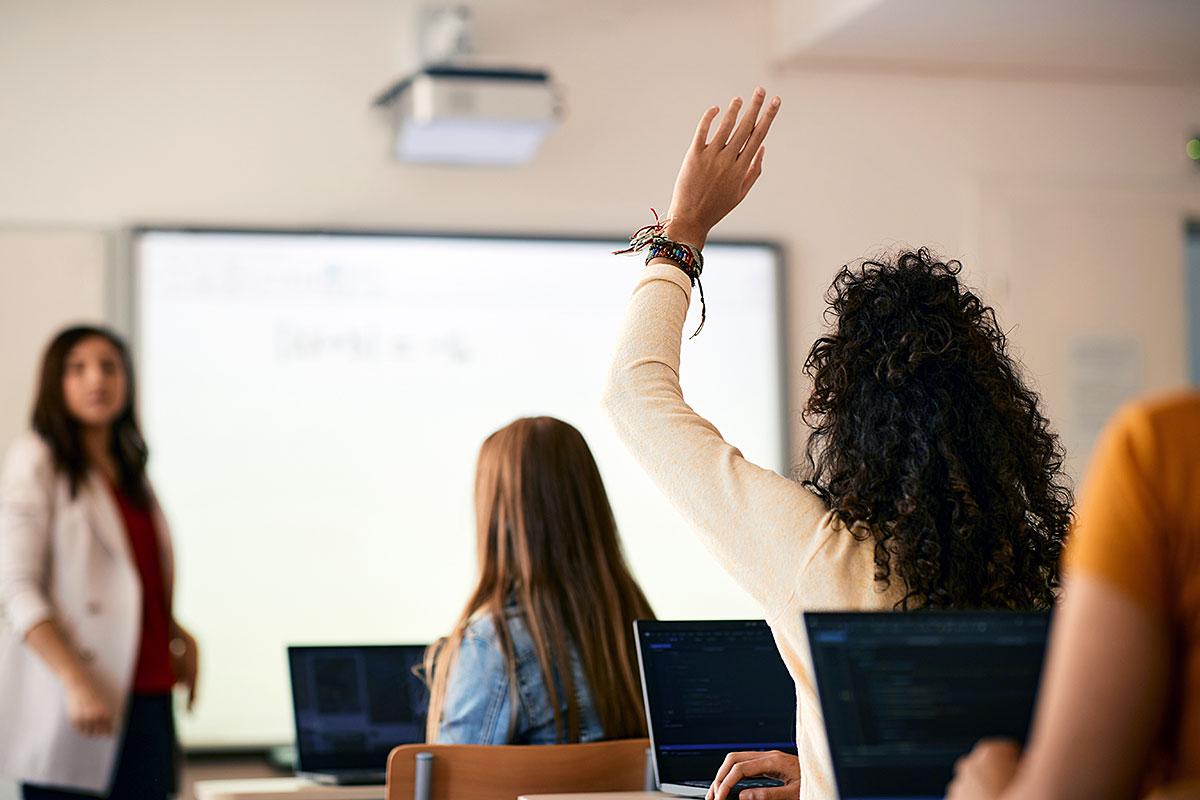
[802,247,1072,609]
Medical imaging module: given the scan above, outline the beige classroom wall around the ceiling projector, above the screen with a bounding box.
[0,0,1200,474]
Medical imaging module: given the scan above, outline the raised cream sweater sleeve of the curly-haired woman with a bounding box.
[604,264,827,618]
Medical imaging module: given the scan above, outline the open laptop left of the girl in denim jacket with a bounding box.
[288,644,428,786]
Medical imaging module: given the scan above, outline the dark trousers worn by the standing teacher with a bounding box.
[20,694,175,800]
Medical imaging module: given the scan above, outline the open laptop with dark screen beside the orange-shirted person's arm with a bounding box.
[804,610,1050,800]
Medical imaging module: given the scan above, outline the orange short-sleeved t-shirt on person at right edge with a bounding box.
[1064,392,1200,786]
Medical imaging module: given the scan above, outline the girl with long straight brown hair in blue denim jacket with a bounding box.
[417,416,654,745]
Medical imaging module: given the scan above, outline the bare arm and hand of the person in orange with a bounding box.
[947,576,1169,800]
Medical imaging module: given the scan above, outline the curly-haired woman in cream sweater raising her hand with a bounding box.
[605,89,1072,800]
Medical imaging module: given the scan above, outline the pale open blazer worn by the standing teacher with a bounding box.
[0,433,174,793]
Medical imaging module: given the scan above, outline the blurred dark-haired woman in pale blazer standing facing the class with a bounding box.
[0,326,198,800]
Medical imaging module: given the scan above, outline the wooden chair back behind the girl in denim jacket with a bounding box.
[386,739,653,800]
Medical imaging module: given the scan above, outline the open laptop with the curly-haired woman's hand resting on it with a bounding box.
[634,620,796,798]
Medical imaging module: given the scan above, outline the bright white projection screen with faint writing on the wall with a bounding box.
[132,229,790,748]
